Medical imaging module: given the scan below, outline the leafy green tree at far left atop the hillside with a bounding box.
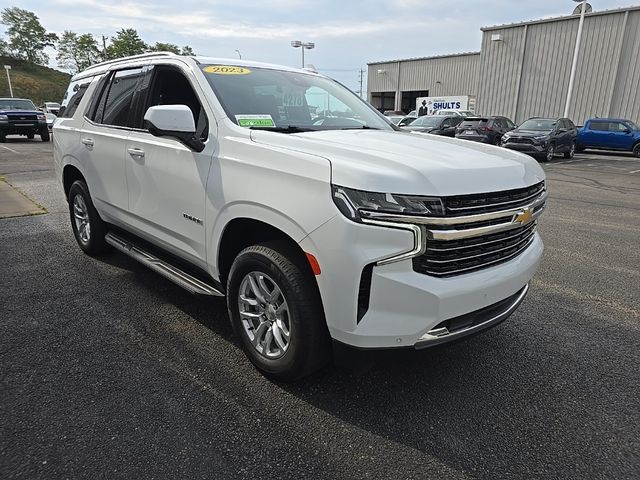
[1,7,58,65]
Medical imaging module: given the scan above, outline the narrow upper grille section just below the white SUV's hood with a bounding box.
[442,182,545,217]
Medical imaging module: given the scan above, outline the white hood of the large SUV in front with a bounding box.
[251,130,544,196]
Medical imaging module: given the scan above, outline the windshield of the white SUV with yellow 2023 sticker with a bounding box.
[202,65,393,133]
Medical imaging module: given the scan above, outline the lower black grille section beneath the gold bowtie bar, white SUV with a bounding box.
[413,222,536,277]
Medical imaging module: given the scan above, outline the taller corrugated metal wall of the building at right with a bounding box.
[478,10,640,124]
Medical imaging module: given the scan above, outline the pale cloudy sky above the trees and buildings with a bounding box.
[0,0,638,92]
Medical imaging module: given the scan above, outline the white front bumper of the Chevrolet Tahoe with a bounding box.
[301,216,543,348]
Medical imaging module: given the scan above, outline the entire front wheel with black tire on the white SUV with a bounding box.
[227,243,330,381]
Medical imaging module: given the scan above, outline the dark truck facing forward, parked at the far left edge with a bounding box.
[0,98,49,143]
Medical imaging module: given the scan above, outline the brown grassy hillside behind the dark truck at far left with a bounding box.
[0,56,71,106]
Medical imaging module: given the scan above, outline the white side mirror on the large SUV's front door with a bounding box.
[144,105,204,152]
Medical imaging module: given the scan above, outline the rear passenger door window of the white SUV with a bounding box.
[92,68,142,127]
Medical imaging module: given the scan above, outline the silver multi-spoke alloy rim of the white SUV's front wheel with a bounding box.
[238,272,291,359]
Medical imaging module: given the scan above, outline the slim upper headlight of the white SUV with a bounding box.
[333,185,444,222]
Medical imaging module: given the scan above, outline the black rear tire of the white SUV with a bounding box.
[69,180,111,256]
